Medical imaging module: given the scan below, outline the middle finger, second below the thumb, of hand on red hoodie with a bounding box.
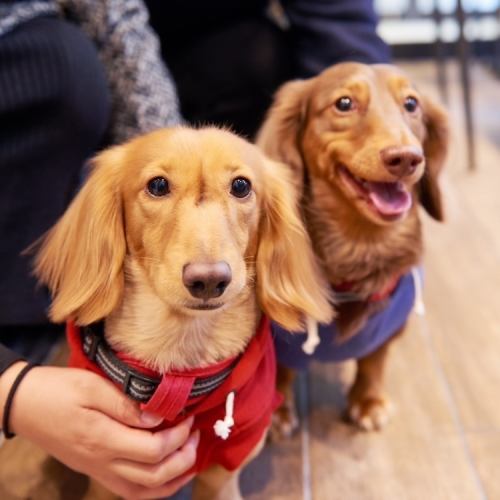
[110,431,200,488]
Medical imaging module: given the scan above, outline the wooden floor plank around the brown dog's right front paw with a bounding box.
[310,321,481,500]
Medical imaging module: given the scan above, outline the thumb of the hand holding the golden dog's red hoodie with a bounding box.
[76,371,163,428]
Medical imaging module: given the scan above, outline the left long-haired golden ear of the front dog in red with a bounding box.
[35,147,126,325]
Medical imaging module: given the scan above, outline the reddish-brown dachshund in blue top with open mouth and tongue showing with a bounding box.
[257,63,448,434]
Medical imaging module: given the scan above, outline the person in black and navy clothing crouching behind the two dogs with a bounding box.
[145,0,390,138]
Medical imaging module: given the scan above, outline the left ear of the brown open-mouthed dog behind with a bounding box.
[256,80,310,182]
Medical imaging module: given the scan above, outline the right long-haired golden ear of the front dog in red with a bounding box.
[256,160,333,331]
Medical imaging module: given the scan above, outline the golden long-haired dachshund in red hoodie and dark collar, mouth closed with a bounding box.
[36,127,331,500]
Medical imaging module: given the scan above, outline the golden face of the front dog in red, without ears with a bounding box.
[121,131,263,315]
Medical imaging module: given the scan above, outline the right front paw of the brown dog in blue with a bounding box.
[348,396,394,432]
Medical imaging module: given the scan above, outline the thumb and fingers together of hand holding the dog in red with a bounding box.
[74,369,199,499]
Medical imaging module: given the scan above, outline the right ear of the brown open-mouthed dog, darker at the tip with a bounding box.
[420,97,449,221]
